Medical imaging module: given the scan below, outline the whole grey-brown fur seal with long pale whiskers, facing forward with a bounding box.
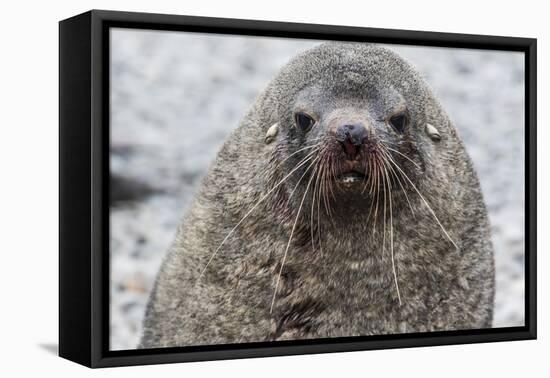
[139,42,494,348]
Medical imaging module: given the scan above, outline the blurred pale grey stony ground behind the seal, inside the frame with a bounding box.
[110,29,524,350]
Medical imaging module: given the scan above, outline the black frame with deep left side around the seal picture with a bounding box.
[59,10,537,367]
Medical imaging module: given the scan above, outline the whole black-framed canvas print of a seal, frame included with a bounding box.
[59,11,536,367]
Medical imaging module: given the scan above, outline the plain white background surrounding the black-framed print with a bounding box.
[0,0,550,377]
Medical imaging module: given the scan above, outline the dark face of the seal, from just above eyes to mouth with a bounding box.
[287,81,422,201]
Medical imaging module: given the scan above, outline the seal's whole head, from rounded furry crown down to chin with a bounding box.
[263,43,446,221]
